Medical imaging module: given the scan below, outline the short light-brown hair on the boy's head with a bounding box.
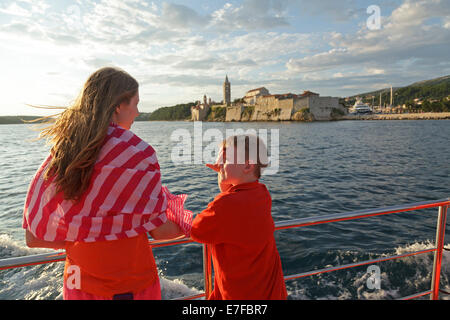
[221,134,269,179]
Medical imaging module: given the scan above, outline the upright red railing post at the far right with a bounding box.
[430,206,448,300]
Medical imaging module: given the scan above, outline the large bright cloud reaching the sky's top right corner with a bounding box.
[286,0,450,77]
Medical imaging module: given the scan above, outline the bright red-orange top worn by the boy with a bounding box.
[191,181,287,300]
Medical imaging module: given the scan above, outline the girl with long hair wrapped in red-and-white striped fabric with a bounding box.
[23,67,192,299]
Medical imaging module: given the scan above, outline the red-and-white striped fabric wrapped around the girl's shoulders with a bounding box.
[23,124,192,242]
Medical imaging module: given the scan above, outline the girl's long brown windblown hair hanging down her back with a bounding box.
[39,67,139,200]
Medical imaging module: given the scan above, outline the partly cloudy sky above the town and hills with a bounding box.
[0,0,450,115]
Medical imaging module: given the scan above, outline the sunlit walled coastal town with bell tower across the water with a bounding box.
[191,76,450,122]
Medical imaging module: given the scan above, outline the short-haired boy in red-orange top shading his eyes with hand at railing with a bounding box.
[191,135,287,300]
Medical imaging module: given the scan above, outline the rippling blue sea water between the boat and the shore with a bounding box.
[0,120,450,299]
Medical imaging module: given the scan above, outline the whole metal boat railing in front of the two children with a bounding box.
[0,198,450,300]
